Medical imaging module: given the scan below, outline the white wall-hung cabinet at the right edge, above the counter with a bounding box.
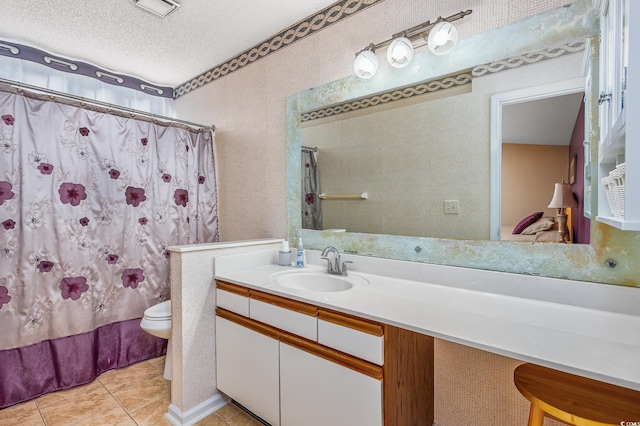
[596,0,640,231]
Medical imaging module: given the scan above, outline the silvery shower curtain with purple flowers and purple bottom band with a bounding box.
[0,86,218,408]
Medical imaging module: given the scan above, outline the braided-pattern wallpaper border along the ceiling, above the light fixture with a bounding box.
[173,0,384,98]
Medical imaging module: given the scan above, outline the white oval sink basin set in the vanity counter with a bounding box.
[270,271,368,293]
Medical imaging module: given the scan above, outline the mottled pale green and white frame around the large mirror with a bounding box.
[287,0,640,286]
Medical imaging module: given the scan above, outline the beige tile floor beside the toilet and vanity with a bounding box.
[0,357,262,426]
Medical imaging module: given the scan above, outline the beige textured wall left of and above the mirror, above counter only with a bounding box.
[176,0,566,241]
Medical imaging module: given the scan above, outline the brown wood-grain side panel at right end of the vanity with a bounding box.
[383,325,434,426]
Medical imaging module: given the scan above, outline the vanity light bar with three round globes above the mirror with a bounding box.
[353,10,472,79]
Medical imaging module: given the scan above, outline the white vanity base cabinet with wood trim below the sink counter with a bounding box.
[216,281,433,426]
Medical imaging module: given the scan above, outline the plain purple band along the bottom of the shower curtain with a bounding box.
[0,318,167,408]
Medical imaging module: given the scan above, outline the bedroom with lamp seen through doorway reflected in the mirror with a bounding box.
[500,93,590,244]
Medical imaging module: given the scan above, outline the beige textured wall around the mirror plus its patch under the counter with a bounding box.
[174,0,584,426]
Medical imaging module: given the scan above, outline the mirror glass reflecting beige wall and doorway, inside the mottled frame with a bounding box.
[301,47,589,243]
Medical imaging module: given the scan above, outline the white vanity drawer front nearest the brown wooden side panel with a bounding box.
[318,319,384,365]
